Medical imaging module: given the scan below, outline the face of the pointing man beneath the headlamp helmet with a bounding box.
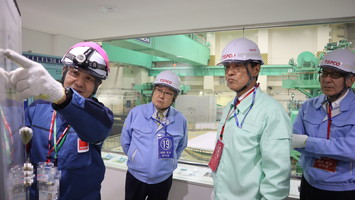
[63,67,96,98]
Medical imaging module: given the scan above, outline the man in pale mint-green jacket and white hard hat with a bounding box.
[209,38,291,200]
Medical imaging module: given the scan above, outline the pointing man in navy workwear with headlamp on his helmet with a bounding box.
[5,42,113,200]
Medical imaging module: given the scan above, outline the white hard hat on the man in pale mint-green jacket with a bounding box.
[218,38,264,65]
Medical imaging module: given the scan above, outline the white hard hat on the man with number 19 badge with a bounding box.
[153,70,181,92]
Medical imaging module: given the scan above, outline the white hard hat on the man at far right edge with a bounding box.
[319,49,355,74]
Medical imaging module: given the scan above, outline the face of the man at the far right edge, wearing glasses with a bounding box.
[319,67,345,96]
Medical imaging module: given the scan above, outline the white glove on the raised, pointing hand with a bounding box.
[5,49,65,103]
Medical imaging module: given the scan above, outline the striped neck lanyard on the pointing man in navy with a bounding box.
[47,111,70,164]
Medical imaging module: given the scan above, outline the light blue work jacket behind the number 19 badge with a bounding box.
[121,103,188,184]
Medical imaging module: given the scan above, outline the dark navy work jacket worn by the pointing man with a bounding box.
[26,90,113,200]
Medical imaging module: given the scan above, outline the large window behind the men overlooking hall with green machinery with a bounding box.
[97,23,355,175]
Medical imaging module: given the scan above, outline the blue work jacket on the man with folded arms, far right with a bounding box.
[293,90,355,191]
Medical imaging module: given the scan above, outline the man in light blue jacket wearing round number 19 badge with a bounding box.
[121,71,188,200]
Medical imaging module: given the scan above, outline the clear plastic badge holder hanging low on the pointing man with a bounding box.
[37,162,61,200]
